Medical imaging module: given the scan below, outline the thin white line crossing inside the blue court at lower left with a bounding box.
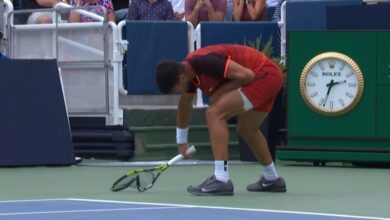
[0,207,179,216]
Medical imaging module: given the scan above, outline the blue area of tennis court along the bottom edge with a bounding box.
[0,199,383,220]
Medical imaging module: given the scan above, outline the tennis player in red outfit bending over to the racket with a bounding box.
[156,44,286,196]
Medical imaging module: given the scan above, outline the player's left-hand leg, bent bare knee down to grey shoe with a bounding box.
[187,90,244,195]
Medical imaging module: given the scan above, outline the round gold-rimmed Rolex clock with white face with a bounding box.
[300,52,364,116]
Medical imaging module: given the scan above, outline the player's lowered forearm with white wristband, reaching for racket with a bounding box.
[176,92,194,156]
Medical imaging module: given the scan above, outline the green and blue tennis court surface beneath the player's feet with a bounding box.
[0,160,390,220]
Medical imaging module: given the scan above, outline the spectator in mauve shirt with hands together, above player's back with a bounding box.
[185,0,227,27]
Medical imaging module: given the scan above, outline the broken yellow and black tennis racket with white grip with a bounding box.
[111,145,196,192]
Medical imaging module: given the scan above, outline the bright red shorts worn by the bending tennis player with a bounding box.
[241,59,283,112]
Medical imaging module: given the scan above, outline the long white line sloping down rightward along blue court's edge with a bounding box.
[67,198,389,220]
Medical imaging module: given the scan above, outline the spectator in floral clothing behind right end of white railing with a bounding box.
[69,0,115,22]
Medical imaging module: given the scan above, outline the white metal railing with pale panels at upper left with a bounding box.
[6,5,127,125]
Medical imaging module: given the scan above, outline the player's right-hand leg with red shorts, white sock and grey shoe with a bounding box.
[237,59,286,192]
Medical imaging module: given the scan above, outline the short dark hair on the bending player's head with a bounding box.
[156,60,184,94]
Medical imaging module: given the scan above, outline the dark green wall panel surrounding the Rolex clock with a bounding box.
[277,31,390,162]
